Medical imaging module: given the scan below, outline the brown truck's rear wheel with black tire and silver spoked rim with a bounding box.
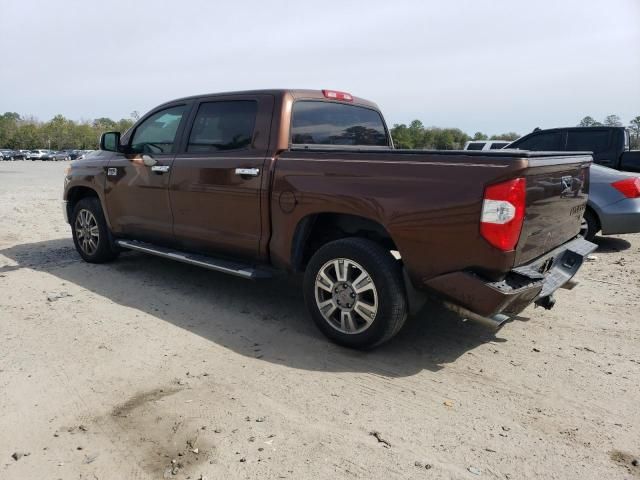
[304,238,407,349]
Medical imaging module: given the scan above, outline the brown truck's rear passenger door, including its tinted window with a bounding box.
[169,95,274,259]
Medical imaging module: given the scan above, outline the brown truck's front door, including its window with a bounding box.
[105,104,189,244]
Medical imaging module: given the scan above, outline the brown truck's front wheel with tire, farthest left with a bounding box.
[71,197,118,263]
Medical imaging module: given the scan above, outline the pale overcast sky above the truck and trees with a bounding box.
[0,0,640,134]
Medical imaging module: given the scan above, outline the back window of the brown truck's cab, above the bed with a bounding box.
[291,101,389,147]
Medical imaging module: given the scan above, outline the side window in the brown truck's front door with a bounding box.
[131,105,186,153]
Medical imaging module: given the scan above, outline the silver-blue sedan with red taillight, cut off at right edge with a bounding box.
[580,165,640,240]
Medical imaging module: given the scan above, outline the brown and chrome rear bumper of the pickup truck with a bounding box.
[427,237,597,324]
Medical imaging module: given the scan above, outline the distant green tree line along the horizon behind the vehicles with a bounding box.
[0,111,640,150]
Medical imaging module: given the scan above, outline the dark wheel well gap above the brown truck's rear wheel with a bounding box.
[291,213,398,272]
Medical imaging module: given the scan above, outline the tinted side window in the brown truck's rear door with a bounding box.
[187,100,258,153]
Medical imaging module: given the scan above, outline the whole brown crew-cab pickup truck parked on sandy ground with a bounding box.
[64,90,595,348]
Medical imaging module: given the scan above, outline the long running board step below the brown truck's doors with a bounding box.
[116,240,273,280]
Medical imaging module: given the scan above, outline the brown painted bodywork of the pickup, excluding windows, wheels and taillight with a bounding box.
[65,90,591,322]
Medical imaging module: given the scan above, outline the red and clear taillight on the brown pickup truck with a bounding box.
[480,178,527,252]
